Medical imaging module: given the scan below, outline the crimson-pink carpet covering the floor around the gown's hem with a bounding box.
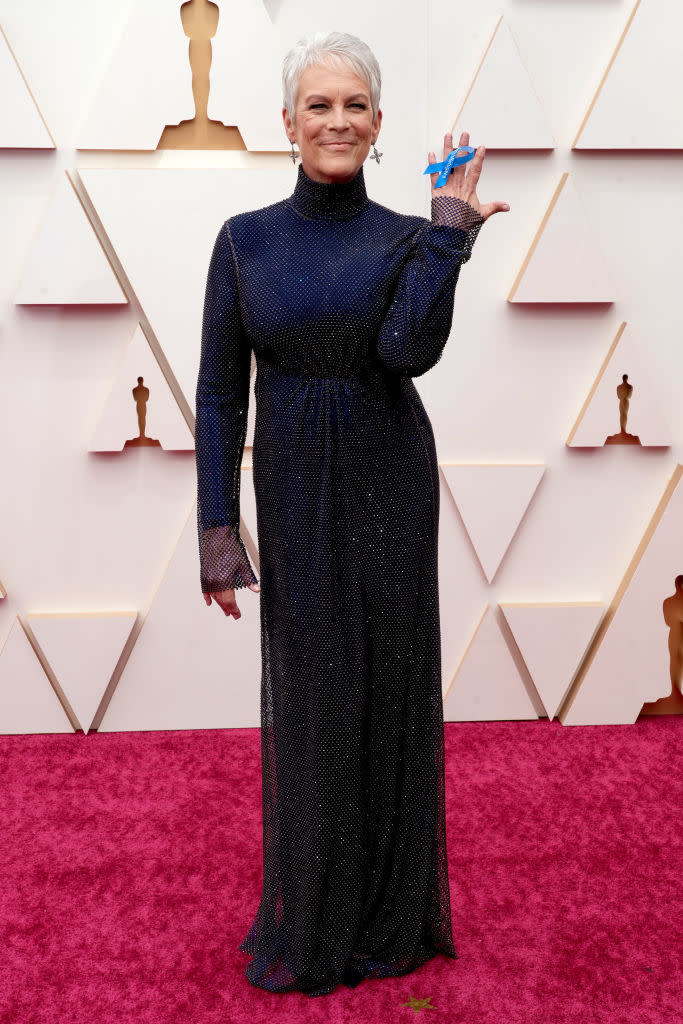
[0,716,683,1024]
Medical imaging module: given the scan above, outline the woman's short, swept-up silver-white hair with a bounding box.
[283,32,382,121]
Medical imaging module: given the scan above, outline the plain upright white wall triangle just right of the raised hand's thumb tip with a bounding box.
[508,173,614,302]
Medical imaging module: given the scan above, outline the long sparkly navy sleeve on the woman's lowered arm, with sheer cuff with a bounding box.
[195,221,258,594]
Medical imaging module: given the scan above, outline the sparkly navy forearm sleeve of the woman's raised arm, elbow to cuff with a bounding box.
[377,196,484,377]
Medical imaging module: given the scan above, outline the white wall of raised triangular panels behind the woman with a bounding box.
[0,0,683,733]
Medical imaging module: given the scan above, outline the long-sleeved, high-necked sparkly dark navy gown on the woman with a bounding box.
[196,167,483,995]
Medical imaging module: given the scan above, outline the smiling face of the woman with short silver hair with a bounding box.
[283,59,382,182]
